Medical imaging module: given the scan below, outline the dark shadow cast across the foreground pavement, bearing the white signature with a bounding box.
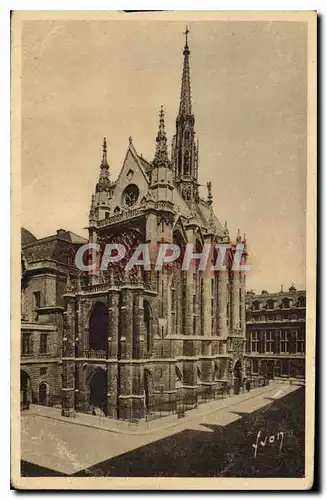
[22,387,305,477]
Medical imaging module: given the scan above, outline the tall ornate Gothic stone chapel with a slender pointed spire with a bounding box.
[62,30,247,419]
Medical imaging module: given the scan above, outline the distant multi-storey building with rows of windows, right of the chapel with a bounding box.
[246,285,306,379]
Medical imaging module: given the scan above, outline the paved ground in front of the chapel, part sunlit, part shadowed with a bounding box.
[22,385,304,477]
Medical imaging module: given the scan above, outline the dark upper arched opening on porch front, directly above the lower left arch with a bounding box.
[89,302,109,353]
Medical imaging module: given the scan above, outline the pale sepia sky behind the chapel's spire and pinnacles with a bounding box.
[22,20,306,292]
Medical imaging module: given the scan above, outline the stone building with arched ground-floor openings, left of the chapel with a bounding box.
[20,229,87,406]
